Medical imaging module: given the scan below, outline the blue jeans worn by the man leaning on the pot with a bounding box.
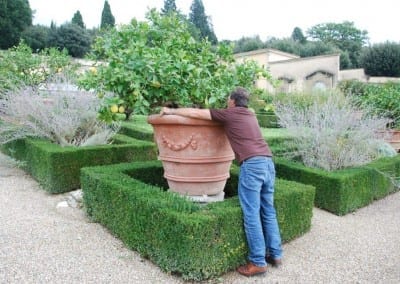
[238,156,282,266]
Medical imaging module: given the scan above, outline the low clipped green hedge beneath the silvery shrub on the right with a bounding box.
[275,155,400,215]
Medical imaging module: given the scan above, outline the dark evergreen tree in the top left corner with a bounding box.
[0,0,32,49]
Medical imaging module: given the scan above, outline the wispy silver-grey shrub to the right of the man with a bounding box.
[274,92,389,171]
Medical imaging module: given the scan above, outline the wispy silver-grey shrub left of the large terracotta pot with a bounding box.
[0,75,119,146]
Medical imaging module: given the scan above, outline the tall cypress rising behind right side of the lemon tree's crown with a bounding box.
[189,0,218,44]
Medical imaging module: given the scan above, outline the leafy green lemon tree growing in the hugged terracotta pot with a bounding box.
[80,10,271,117]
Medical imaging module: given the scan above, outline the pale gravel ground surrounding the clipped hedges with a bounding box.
[0,153,400,284]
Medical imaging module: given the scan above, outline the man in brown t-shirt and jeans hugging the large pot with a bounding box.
[161,87,282,276]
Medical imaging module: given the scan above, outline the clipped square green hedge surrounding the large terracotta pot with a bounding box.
[81,161,315,280]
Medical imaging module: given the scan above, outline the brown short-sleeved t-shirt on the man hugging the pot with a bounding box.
[210,107,272,163]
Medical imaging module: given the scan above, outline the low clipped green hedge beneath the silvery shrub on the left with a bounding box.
[2,135,157,193]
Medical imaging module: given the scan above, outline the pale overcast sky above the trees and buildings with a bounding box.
[29,0,400,43]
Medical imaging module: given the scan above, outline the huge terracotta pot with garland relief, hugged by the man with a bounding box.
[147,115,234,199]
